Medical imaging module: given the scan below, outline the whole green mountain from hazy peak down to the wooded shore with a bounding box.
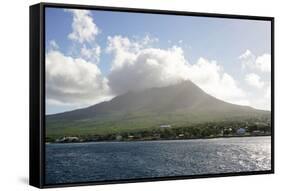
[46,81,271,142]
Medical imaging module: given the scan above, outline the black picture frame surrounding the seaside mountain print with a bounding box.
[29,3,274,188]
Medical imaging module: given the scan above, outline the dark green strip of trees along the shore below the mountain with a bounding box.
[46,114,271,142]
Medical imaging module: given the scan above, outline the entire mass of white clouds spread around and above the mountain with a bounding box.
[46,9,271,112]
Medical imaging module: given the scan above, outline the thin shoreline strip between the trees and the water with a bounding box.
[45,134,271,144]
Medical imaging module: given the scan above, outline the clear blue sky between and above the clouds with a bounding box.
[46,8,271,113]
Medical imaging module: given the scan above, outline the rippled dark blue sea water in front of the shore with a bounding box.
[45,136,271,184]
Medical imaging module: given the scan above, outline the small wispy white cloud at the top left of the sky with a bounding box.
[66,9,100,43]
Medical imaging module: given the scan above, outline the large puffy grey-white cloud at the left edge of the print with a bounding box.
[46,51,109,105]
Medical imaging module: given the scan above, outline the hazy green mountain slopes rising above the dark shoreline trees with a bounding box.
[46,81,270,140]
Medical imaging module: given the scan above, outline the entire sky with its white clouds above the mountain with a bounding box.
[45,8,271,114]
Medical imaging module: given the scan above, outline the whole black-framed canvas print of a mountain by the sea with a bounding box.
[30,3,274,188]
